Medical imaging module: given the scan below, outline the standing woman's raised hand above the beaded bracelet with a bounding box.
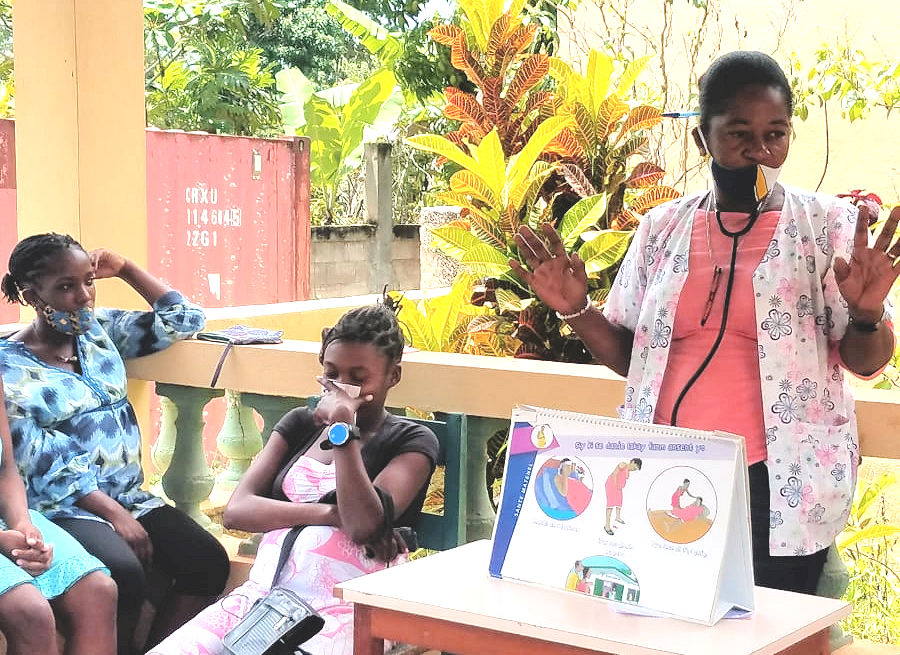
[509,223,587,314]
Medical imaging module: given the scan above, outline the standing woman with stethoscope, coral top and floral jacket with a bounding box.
[511,52,900,593]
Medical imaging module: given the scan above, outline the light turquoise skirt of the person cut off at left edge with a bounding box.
[0,444,109,599]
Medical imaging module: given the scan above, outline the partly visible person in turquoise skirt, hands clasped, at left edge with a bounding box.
[0,385,116,655]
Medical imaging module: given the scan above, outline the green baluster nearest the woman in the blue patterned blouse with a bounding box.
[156,382,222,534]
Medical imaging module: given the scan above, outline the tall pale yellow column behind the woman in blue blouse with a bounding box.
[13,0,150,472]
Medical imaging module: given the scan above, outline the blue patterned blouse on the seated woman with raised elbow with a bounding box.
[0,291,205,521]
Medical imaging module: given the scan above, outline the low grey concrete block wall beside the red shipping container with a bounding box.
[310,225,420,298]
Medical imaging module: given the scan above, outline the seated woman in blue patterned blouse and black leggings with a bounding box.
[0,234,229,652]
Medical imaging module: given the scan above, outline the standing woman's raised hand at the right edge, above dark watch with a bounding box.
[834,206,900,323]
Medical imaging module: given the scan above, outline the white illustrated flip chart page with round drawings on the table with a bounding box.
[490,408,740,622]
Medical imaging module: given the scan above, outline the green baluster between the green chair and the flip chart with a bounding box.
[466,416,509,542]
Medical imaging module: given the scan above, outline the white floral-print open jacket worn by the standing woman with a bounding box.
[603,187,880,555]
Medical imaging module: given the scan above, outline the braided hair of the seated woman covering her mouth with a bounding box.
[319,302,406,364]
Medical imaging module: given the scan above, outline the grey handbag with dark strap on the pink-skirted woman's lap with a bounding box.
[222,526,325,655]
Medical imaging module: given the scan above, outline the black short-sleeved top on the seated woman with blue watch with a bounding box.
[271,407,438,527]
